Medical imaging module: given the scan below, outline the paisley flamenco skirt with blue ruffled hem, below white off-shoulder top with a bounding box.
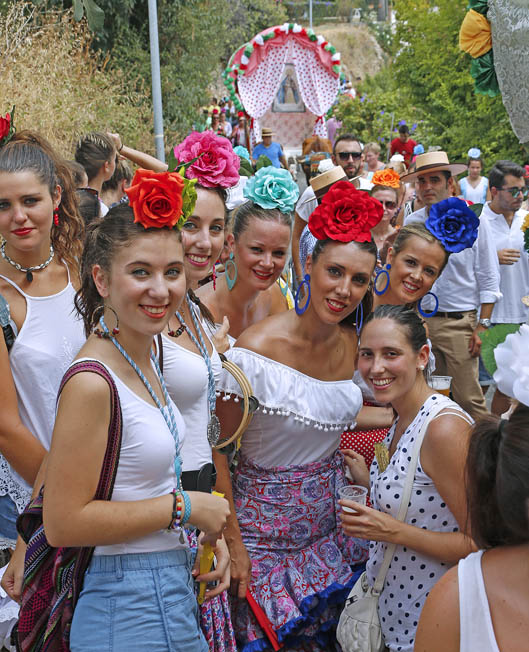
[232,453,368,652]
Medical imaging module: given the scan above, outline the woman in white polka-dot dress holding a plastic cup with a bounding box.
[340,305,472,652]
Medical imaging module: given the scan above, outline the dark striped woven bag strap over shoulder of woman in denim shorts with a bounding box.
[57,360,123,500]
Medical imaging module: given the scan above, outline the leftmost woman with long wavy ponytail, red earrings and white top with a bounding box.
[0,131,85,548]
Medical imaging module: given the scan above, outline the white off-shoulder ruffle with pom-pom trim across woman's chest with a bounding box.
[217,347,362,432]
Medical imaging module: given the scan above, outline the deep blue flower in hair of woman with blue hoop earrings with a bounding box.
[424,197,483,254]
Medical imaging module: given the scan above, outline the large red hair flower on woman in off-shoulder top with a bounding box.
[309,181,384,242]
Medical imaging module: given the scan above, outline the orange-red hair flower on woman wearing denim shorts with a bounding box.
[125,168,196,229]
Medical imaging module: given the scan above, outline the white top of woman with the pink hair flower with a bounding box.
[162,328,222,471]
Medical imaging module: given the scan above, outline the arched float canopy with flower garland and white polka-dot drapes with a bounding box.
[223,23,340,142]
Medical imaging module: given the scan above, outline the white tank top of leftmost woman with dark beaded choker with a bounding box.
[0,272,86,512]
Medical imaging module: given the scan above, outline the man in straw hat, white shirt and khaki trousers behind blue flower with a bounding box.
[401,152,501,419]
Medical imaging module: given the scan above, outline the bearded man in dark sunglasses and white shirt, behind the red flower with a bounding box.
[292,134,373,282]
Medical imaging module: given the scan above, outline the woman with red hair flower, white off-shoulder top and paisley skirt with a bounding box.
[214,182,383,651]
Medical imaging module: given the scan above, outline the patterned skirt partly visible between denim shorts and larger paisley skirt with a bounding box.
[186,530,237,652]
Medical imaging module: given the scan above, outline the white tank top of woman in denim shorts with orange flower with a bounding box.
[73,358,188,555]
